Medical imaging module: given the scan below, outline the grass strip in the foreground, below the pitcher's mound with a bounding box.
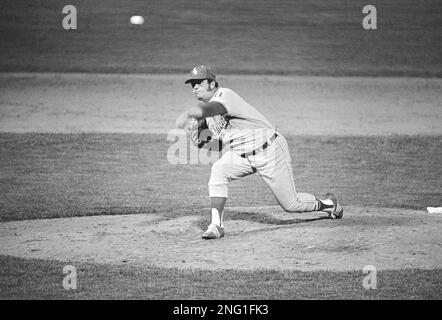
[0,256,442,300]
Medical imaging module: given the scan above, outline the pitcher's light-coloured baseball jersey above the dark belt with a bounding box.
[206,88,275,154]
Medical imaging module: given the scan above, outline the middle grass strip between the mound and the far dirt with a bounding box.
[0,133,442,221]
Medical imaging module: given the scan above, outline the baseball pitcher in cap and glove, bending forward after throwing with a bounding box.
[176,65,344,239]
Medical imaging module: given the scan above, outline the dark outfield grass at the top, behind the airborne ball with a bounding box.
[0,0,442,77]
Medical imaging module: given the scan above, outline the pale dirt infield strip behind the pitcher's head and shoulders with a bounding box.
[0,73,442,136]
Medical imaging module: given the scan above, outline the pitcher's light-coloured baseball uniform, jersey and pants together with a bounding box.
[206,88,318,212]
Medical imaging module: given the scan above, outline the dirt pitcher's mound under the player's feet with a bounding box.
[0,207,442,271]
